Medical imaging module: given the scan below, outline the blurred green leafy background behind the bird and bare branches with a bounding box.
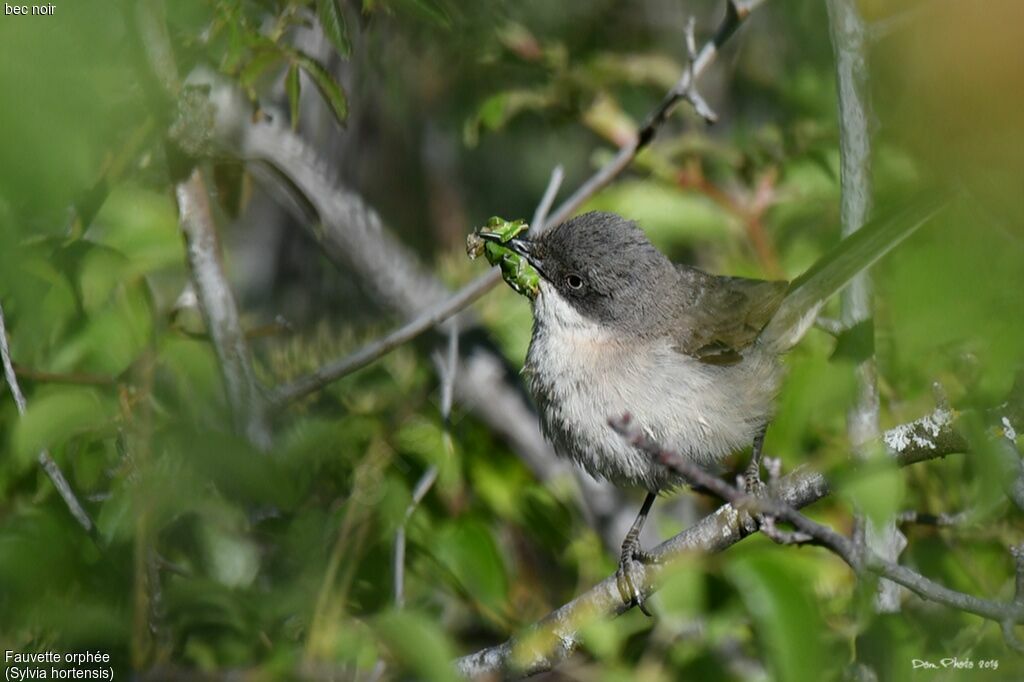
[0,0,1024,680]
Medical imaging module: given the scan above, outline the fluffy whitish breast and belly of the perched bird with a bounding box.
[523,284,780,491]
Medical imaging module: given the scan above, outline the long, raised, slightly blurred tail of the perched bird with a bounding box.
[758,191,946,352]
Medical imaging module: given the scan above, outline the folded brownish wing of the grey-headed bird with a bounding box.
[676,267,788,365]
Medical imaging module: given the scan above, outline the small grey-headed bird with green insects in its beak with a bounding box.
[481,199,935,607]
